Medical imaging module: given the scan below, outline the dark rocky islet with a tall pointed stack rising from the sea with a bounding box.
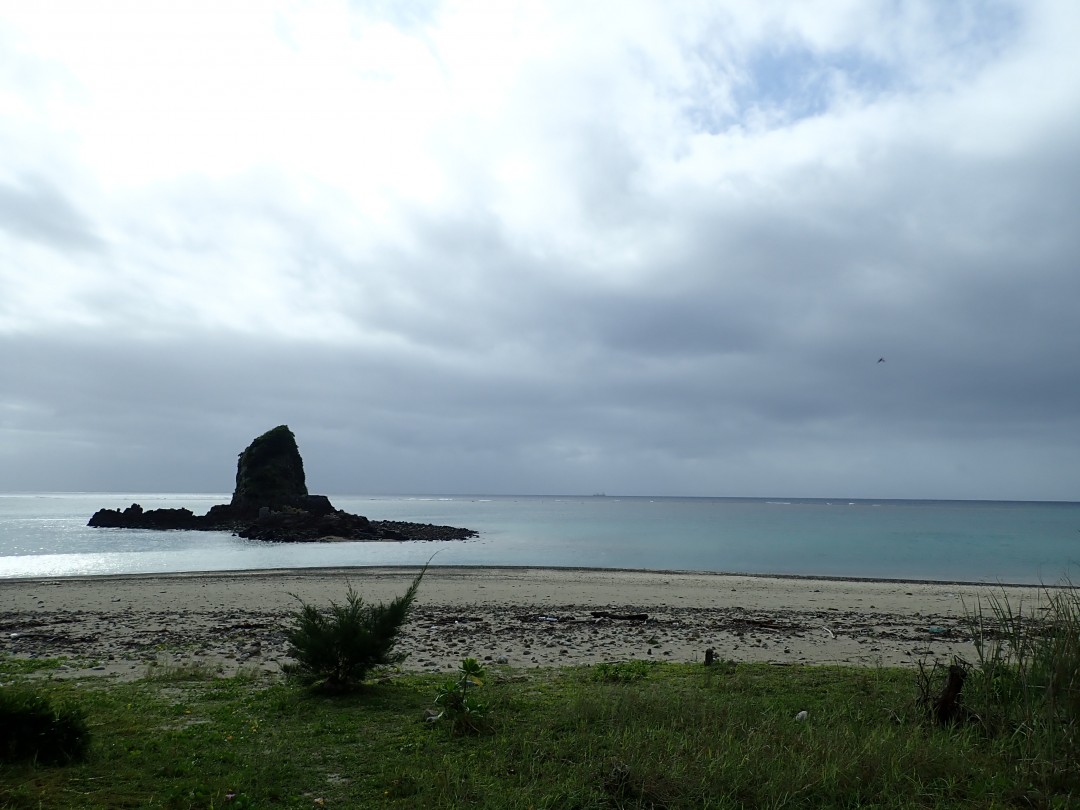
[89,424,476,542]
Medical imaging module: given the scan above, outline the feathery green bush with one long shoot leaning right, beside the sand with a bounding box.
[285,566,428,691]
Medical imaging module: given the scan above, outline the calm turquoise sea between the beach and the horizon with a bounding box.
[0,494,1080,584]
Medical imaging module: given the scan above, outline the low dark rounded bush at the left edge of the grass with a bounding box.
[0,687,90,765]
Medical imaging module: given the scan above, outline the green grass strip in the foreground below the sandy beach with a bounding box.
[0,662,1080,809]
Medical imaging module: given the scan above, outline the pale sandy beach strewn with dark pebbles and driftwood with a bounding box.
[0,567,1045,678]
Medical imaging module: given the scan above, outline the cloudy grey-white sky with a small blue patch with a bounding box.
[0,0,1080,500]
